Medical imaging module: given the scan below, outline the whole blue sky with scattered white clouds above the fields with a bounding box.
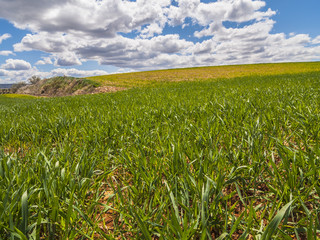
[0,0,320,84]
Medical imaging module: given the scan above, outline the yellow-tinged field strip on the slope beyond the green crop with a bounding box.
[88,62,320,87]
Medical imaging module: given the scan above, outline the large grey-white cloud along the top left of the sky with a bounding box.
[0,0,171,38]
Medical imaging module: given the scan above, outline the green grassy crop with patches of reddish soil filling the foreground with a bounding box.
[0,63,320,240]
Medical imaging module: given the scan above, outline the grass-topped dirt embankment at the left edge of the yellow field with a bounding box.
[13,76,124,97]
